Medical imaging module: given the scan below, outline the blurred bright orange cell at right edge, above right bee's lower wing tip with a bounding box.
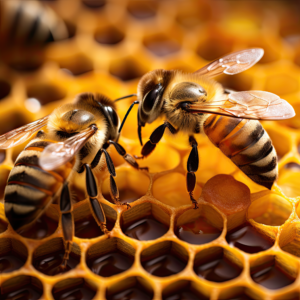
[264,72,299,95]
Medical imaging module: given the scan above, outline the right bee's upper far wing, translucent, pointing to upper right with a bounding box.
[194,48,264,77]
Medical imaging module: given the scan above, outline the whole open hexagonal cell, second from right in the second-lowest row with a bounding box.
[194,247,243,282]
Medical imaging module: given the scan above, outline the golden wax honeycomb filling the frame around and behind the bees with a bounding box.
[0,0,300,300]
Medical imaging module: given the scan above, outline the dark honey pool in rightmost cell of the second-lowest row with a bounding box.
[251,260,295,290]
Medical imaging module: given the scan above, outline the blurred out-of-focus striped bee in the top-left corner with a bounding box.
[0,0,69,68]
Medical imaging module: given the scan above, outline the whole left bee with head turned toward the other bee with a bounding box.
[0,93,139,268]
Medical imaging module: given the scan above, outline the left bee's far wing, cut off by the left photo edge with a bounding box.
[0,116,49,149]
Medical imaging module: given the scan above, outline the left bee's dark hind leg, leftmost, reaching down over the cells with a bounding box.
[59,182,74,270]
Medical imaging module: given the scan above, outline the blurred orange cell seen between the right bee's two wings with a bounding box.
[218,72,253,91]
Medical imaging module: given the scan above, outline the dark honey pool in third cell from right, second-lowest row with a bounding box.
[142,254,187,277]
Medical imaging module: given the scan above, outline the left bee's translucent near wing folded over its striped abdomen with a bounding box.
[39,127,97,170]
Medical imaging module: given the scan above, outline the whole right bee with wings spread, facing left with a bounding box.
[117,48,295,208]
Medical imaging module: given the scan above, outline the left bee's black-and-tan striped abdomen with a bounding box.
[4,140,73,230]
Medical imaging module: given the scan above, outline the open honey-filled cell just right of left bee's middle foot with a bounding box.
[120,202,170,241]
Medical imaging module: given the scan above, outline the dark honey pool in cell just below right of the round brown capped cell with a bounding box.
[226,223,274,253]
